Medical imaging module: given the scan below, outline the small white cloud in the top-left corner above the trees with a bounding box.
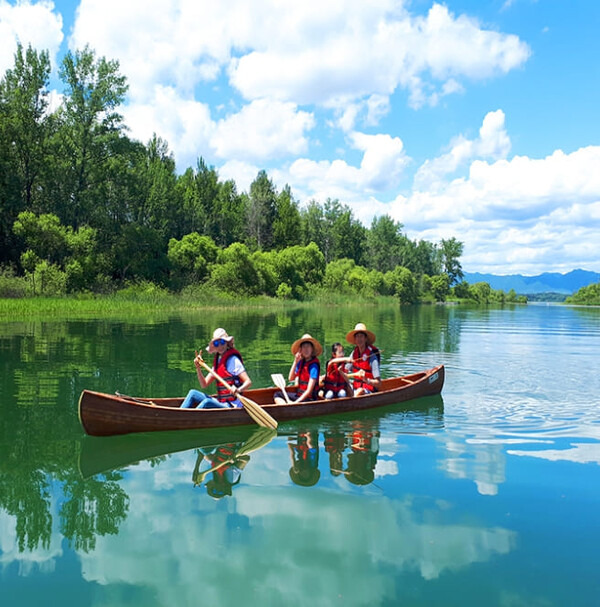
[0,0,63,78]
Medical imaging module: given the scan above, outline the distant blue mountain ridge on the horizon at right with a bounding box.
[464,270,600,295]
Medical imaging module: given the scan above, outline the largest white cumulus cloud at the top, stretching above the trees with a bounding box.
[61,0,529,163]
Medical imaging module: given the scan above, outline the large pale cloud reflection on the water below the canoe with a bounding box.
[75,456,516,605]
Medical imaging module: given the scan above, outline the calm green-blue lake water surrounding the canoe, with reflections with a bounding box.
[0,305,600,607]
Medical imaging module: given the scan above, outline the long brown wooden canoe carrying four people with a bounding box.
[79,365,444,436]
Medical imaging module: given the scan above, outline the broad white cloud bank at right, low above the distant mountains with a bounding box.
[389,146,600,274]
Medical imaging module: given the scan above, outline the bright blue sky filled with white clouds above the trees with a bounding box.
[0,0,600,275]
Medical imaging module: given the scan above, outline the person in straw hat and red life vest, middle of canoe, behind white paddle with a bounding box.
[275,333,323,404]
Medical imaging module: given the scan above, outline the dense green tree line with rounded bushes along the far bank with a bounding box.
[0,45,504,302]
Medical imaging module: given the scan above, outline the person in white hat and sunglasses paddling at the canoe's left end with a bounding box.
[181,327,252,409]
